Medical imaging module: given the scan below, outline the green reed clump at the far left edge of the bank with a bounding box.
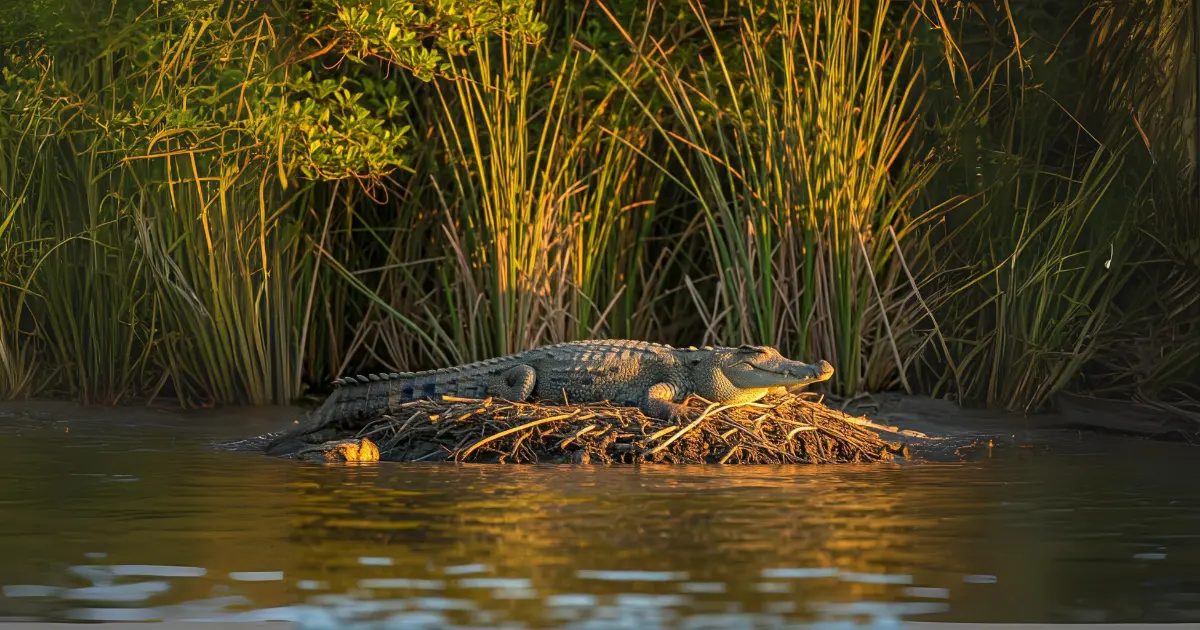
[2,45,157,402]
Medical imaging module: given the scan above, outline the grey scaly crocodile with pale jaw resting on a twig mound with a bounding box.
[266,340,834,452]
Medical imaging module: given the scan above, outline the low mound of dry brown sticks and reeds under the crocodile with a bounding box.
[278,392,901,464]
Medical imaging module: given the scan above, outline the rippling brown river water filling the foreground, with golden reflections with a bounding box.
[0,400,1200,629]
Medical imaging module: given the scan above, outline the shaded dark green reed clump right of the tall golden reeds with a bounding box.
[923,0,1140,410]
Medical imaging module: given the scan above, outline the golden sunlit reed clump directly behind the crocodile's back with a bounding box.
[422,30,654,360]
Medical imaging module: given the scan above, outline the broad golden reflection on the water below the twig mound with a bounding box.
[274,467,978,614]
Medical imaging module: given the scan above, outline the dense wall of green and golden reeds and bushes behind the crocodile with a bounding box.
[0,0,1200,409]
